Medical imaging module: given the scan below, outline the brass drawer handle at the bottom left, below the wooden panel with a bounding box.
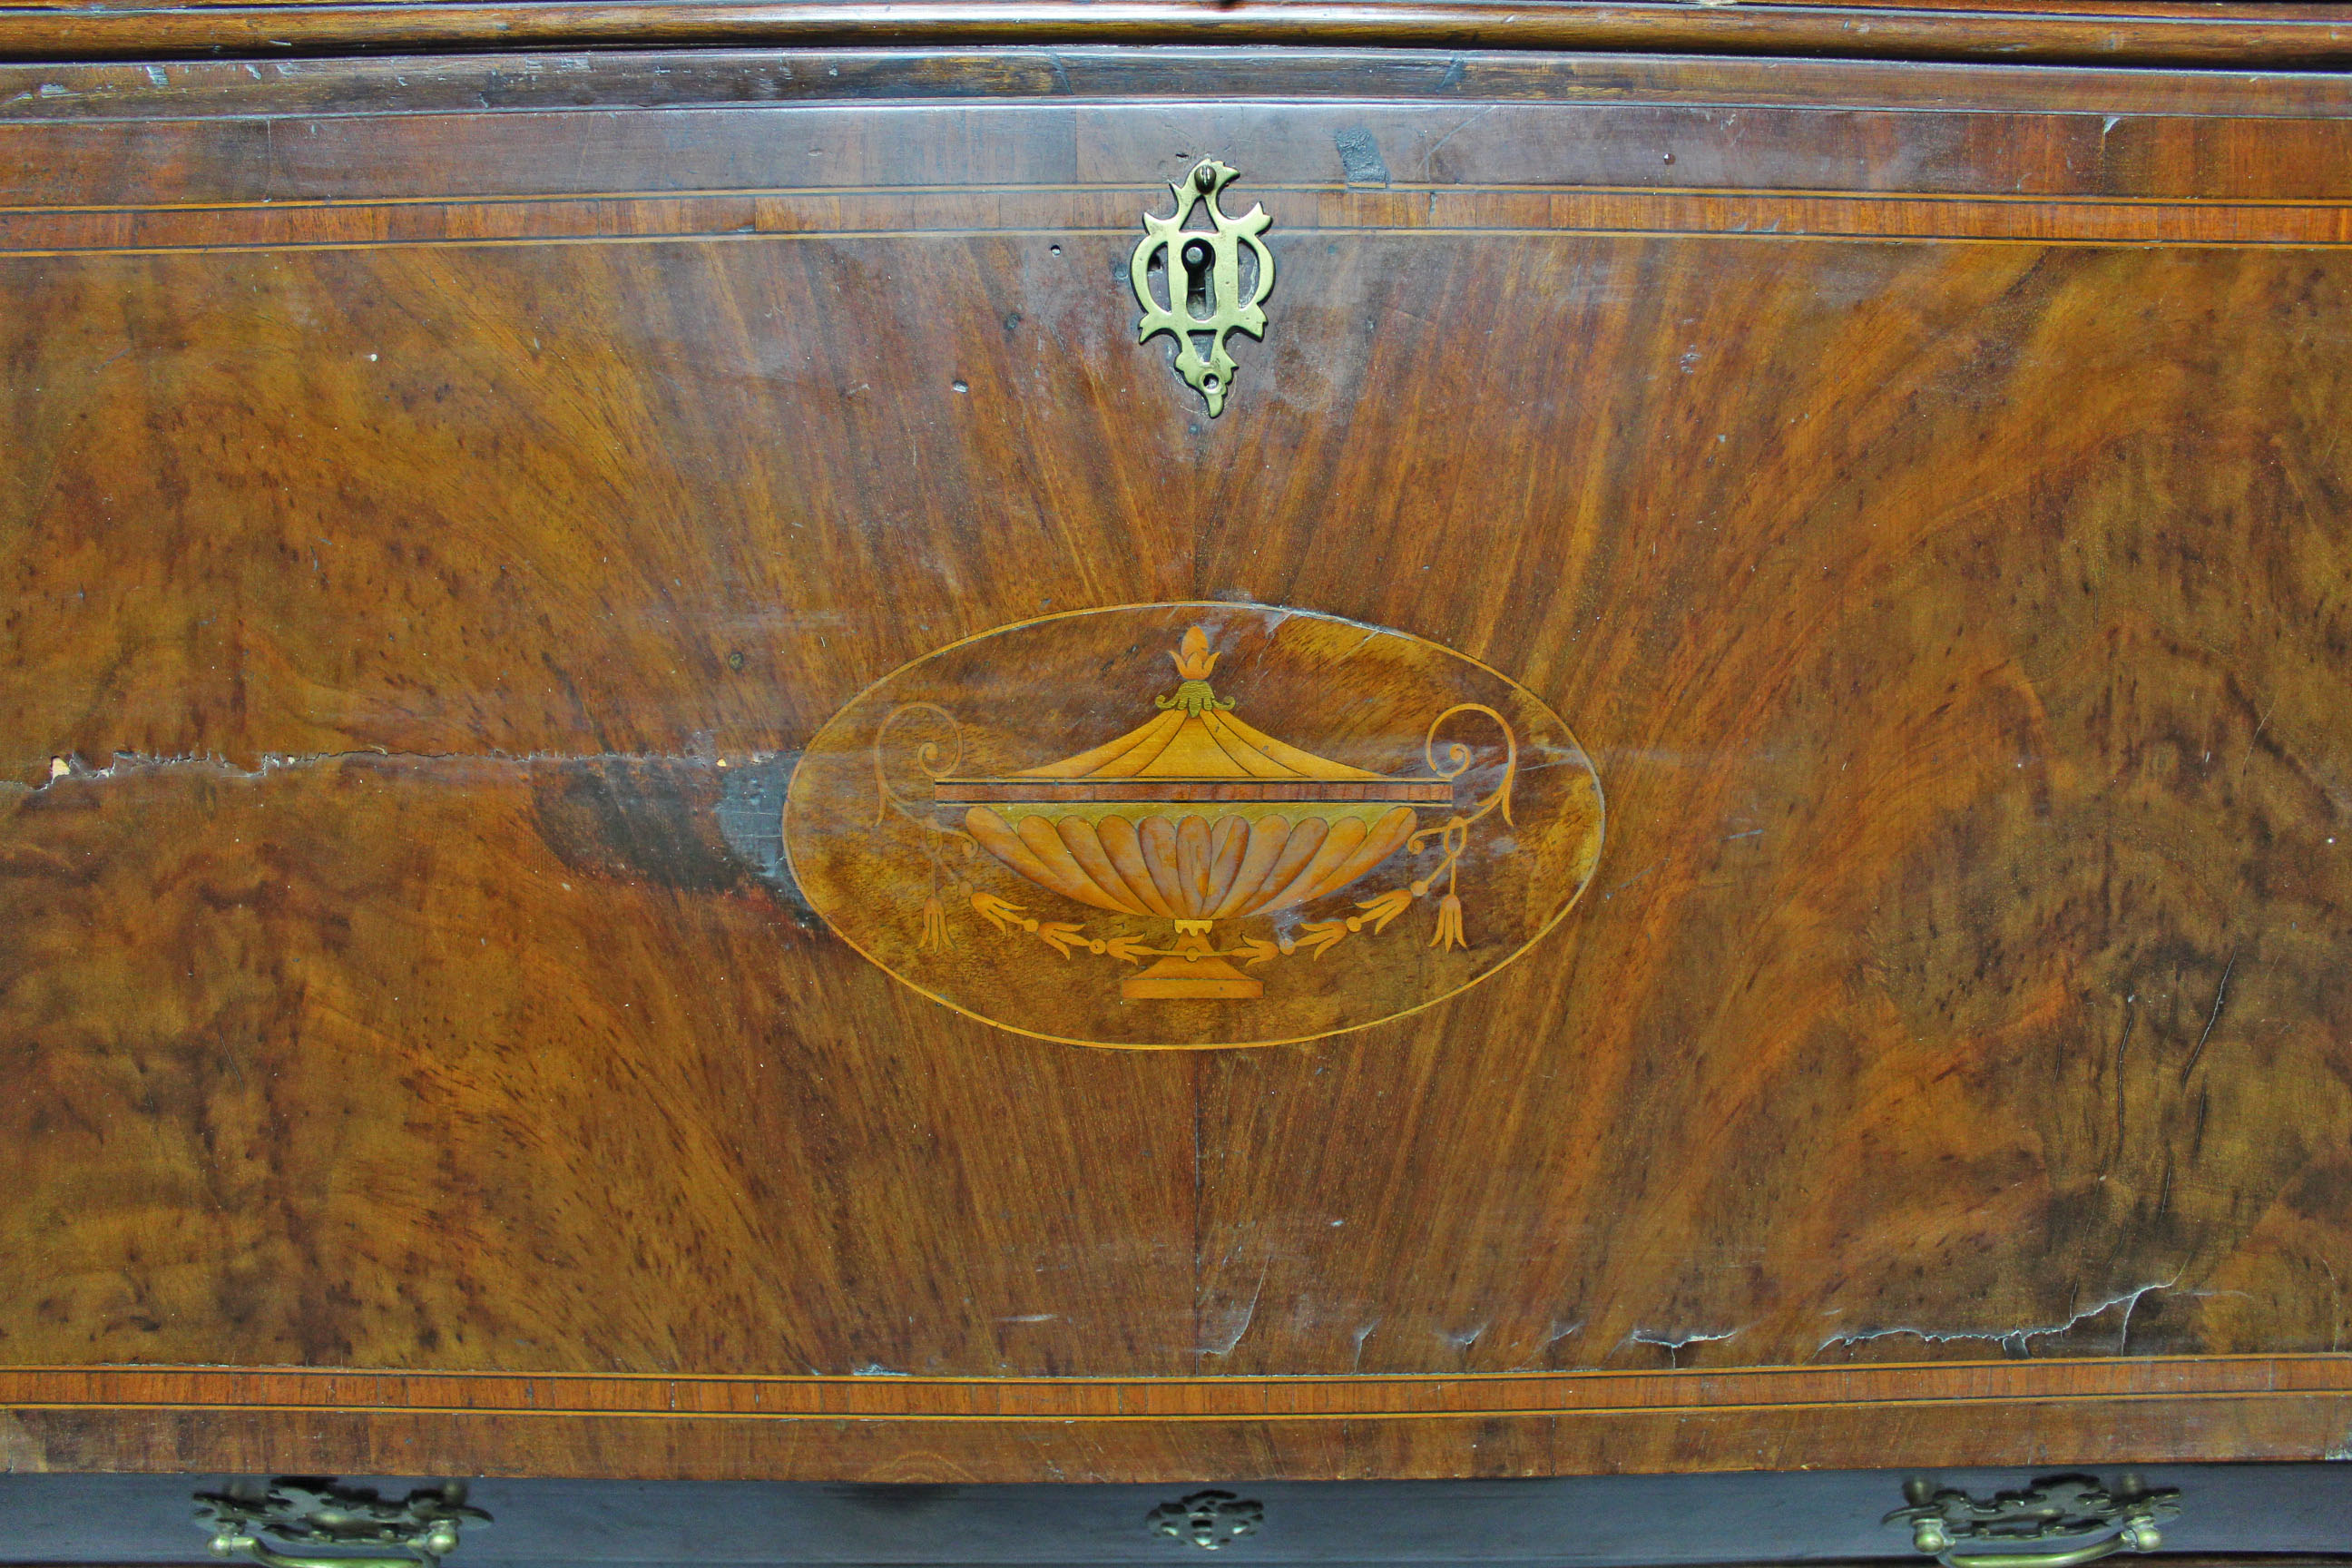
[195,1476,489,1568]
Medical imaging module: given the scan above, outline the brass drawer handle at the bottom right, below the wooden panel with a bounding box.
[1886,1476,2180,1568]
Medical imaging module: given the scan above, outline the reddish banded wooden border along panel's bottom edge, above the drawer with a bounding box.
[0,1354,2352,1481]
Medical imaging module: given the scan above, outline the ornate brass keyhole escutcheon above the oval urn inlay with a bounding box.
[1127,158,1275,418]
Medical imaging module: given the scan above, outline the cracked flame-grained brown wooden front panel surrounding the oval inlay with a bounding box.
[0,43,2352,1479]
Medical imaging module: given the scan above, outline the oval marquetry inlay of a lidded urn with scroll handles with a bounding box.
[783,604,1602,1048]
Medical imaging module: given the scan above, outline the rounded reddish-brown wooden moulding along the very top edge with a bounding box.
[0,0,2352,68]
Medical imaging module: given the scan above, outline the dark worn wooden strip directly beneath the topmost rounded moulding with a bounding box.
[14,45,2352,127]
